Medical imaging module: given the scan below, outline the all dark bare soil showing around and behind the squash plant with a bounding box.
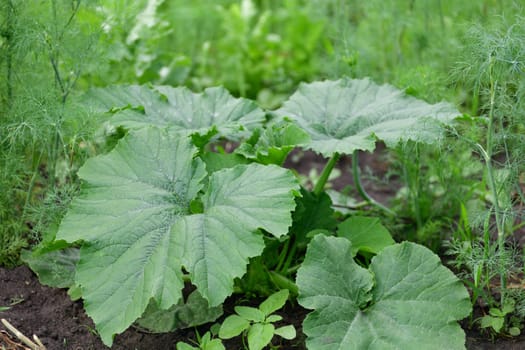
[0,148,525,350]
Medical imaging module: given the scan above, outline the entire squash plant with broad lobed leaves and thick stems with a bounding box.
[26,78,470,349]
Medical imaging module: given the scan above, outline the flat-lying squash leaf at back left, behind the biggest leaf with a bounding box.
[87,85,265,138]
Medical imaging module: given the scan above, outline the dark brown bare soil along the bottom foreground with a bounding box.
[0,266,525,350]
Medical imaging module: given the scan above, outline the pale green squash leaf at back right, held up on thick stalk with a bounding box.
[276,78,460,157]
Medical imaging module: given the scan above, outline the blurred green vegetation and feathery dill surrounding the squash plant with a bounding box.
[0,0,525,340]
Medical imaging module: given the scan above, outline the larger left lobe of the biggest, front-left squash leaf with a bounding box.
[57,128,206,343]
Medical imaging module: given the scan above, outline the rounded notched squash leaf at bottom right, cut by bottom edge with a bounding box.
[297,235,471,350]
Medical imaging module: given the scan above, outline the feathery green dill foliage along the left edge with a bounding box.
[0,0,102,266]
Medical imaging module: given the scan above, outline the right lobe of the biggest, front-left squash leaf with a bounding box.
[176,164,299,307]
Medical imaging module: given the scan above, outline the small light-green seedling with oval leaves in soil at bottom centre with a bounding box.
[219,289,296,350]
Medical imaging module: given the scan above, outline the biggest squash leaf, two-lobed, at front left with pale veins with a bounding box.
[57,128,298,344]
